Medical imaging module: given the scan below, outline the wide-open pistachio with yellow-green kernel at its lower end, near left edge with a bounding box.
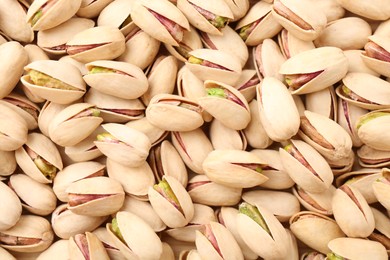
[15,133,63,183]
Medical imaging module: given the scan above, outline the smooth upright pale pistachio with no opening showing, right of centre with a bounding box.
[256,77,300,141]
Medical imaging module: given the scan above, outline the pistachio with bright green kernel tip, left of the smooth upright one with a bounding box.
[198,80,251,130]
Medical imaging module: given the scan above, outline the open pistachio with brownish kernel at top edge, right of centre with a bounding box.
[235,1,282,46]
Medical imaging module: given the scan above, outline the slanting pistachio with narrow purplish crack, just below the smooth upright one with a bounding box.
[279,140,333,193]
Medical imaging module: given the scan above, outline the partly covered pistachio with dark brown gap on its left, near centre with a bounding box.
[148,140,188,187]
